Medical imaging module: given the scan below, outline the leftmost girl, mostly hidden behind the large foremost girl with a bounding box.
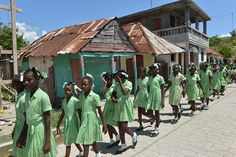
[11,75,26,157]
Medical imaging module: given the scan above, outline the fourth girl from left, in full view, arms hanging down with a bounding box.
[76,74,107,157]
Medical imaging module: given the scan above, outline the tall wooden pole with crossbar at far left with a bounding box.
[0,0,22,75]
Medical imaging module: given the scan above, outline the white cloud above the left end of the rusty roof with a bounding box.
[16,22,47,43]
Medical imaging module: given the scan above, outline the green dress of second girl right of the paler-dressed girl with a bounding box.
[199,69,212,98]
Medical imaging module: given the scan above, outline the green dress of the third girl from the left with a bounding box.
[62,96,79,146]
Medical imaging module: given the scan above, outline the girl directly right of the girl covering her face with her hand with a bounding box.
[134,67,154,131]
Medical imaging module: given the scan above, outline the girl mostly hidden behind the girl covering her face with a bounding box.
[102,72,120,147]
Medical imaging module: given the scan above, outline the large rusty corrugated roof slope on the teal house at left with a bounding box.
[18,18,122,58]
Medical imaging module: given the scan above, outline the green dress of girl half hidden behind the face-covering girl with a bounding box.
[103,85,117,126]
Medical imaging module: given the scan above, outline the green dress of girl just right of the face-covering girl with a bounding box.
[134,77,148,109]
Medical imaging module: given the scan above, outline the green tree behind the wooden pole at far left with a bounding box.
[0,23,28,50]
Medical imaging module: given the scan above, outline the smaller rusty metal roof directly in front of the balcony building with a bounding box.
[123,22,184,55]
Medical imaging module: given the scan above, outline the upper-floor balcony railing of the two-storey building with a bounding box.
[154,26,208,41]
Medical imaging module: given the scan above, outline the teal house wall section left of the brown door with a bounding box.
[54,54,73,97]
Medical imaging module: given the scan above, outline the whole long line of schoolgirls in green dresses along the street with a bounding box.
[12,62,236,157]
